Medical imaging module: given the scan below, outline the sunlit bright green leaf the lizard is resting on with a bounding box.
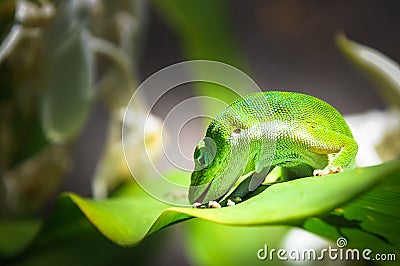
[53,161,400,246]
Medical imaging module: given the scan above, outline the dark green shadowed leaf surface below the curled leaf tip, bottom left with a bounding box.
[6,193,171,266]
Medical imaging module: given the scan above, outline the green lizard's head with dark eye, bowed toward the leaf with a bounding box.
[189,120,245,204]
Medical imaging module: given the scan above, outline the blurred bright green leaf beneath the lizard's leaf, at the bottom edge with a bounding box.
[183,219,290,266]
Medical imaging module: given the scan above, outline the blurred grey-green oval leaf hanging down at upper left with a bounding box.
[41,2,93,143]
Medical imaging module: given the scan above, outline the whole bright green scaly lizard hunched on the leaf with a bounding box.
[189,91,358,207]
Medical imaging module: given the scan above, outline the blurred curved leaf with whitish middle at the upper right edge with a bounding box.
[336,34,400,107]
